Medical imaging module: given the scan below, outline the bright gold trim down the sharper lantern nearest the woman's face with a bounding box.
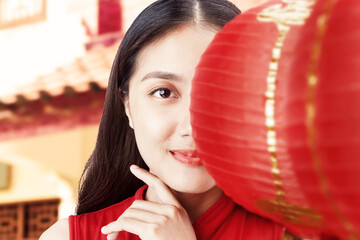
[256,0,322,226]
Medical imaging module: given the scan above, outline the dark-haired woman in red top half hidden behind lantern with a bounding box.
[41,0,283,240]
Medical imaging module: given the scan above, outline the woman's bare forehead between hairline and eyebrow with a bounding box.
[133,26,215,80]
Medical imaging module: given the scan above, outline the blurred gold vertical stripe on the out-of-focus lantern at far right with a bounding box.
[306,0,360,239]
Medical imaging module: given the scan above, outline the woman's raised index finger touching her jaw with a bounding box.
[130,165,181,207]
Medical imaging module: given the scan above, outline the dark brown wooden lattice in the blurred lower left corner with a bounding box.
[0,199,60,240]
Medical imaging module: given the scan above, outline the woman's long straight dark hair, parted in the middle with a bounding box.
[76,0,240,214]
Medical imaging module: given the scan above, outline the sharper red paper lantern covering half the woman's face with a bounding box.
[190,0,321,235]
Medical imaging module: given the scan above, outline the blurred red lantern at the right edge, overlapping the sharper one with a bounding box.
[285,0,360,239]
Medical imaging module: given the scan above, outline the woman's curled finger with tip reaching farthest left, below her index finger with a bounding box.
[101,217,148,235]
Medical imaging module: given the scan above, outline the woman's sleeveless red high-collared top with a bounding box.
[69,185,284,240]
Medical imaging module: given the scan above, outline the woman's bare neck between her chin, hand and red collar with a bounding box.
[146,186,223,223]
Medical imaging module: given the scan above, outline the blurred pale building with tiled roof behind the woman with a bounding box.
[0,0,266,240]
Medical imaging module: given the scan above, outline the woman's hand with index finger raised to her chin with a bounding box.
[101,165,196,240]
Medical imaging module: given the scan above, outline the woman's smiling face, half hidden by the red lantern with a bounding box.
[125,26,215,193]
